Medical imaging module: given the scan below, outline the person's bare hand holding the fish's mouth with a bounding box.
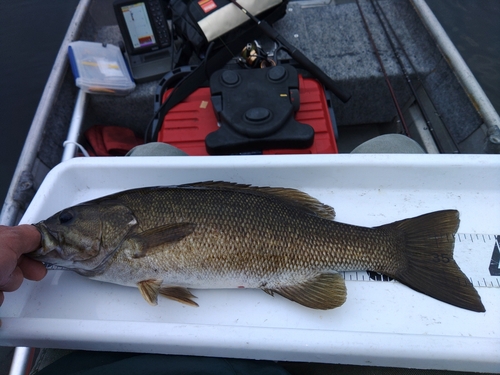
[0,225,47,305]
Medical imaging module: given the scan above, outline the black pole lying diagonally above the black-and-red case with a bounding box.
[230,0,351,103]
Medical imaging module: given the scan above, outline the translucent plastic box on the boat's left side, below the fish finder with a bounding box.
[68,41,135,95]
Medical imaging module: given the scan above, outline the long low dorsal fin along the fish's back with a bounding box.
[177,181,335,220]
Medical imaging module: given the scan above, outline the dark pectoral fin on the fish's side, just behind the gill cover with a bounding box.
[122,223,196,258]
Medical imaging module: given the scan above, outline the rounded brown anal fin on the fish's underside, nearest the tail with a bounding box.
[263,273,347,310]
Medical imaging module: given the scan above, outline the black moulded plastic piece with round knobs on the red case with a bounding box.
[205,65,314,155]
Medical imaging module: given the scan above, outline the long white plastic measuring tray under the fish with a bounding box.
[0,154,500,373]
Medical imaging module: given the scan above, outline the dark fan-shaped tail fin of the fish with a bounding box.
[379,210,486,312]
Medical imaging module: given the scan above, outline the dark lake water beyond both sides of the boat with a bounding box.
[0,0,500,206]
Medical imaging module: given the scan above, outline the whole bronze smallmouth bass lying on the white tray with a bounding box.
[30,182,485,312]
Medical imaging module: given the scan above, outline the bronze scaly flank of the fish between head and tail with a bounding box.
[111,189,392,287]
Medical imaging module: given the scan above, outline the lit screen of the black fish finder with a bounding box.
[121,2,156,48]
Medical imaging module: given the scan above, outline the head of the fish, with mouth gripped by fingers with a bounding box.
[28,201,137,276]
